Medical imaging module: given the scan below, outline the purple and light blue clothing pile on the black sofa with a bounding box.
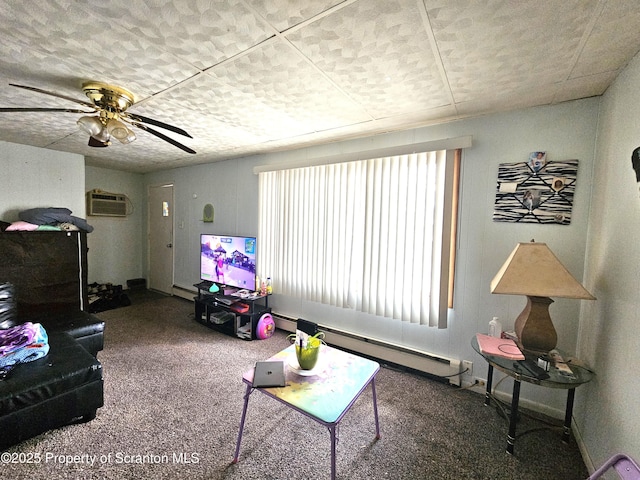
[0,322,49,379]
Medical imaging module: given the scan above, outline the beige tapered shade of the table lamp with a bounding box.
[491,242,595,300]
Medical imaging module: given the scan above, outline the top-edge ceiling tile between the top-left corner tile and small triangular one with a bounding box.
[80,0,273,69]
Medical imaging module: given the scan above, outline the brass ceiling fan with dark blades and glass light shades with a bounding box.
[0,82,196,153]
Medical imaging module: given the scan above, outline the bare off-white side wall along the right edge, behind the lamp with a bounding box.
[576,51,640,466]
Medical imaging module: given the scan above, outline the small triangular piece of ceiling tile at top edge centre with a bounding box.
[246,0,344,32]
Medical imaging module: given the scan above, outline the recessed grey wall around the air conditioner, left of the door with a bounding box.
[83,166,147,288]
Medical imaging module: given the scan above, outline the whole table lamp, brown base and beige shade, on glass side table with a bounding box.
[491,241,595,352]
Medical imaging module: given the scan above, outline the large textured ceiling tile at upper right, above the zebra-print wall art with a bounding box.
[427,0,597,102]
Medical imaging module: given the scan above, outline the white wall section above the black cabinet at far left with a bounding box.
[0,141,85,222]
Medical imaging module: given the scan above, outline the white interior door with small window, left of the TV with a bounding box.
[148,185,173,294]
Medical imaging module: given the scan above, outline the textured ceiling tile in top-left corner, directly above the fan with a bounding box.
[0,1,197,97]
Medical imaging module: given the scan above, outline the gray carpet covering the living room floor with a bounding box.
[0,296,588,480]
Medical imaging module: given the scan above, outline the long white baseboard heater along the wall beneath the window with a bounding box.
[173,285,462,386]
